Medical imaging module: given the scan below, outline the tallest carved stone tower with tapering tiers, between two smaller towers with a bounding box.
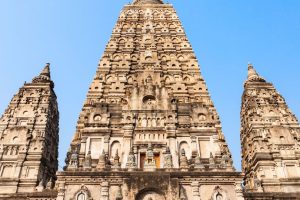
[57,0,243,200]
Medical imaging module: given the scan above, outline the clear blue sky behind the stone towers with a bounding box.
[0,0,300,169]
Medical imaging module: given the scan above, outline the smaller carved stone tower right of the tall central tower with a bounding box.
[241,64,300,197]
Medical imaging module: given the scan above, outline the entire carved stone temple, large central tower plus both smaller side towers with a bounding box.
[0,0,300,200]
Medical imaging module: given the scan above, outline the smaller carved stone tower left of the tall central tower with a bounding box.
[0,64,59,197]
